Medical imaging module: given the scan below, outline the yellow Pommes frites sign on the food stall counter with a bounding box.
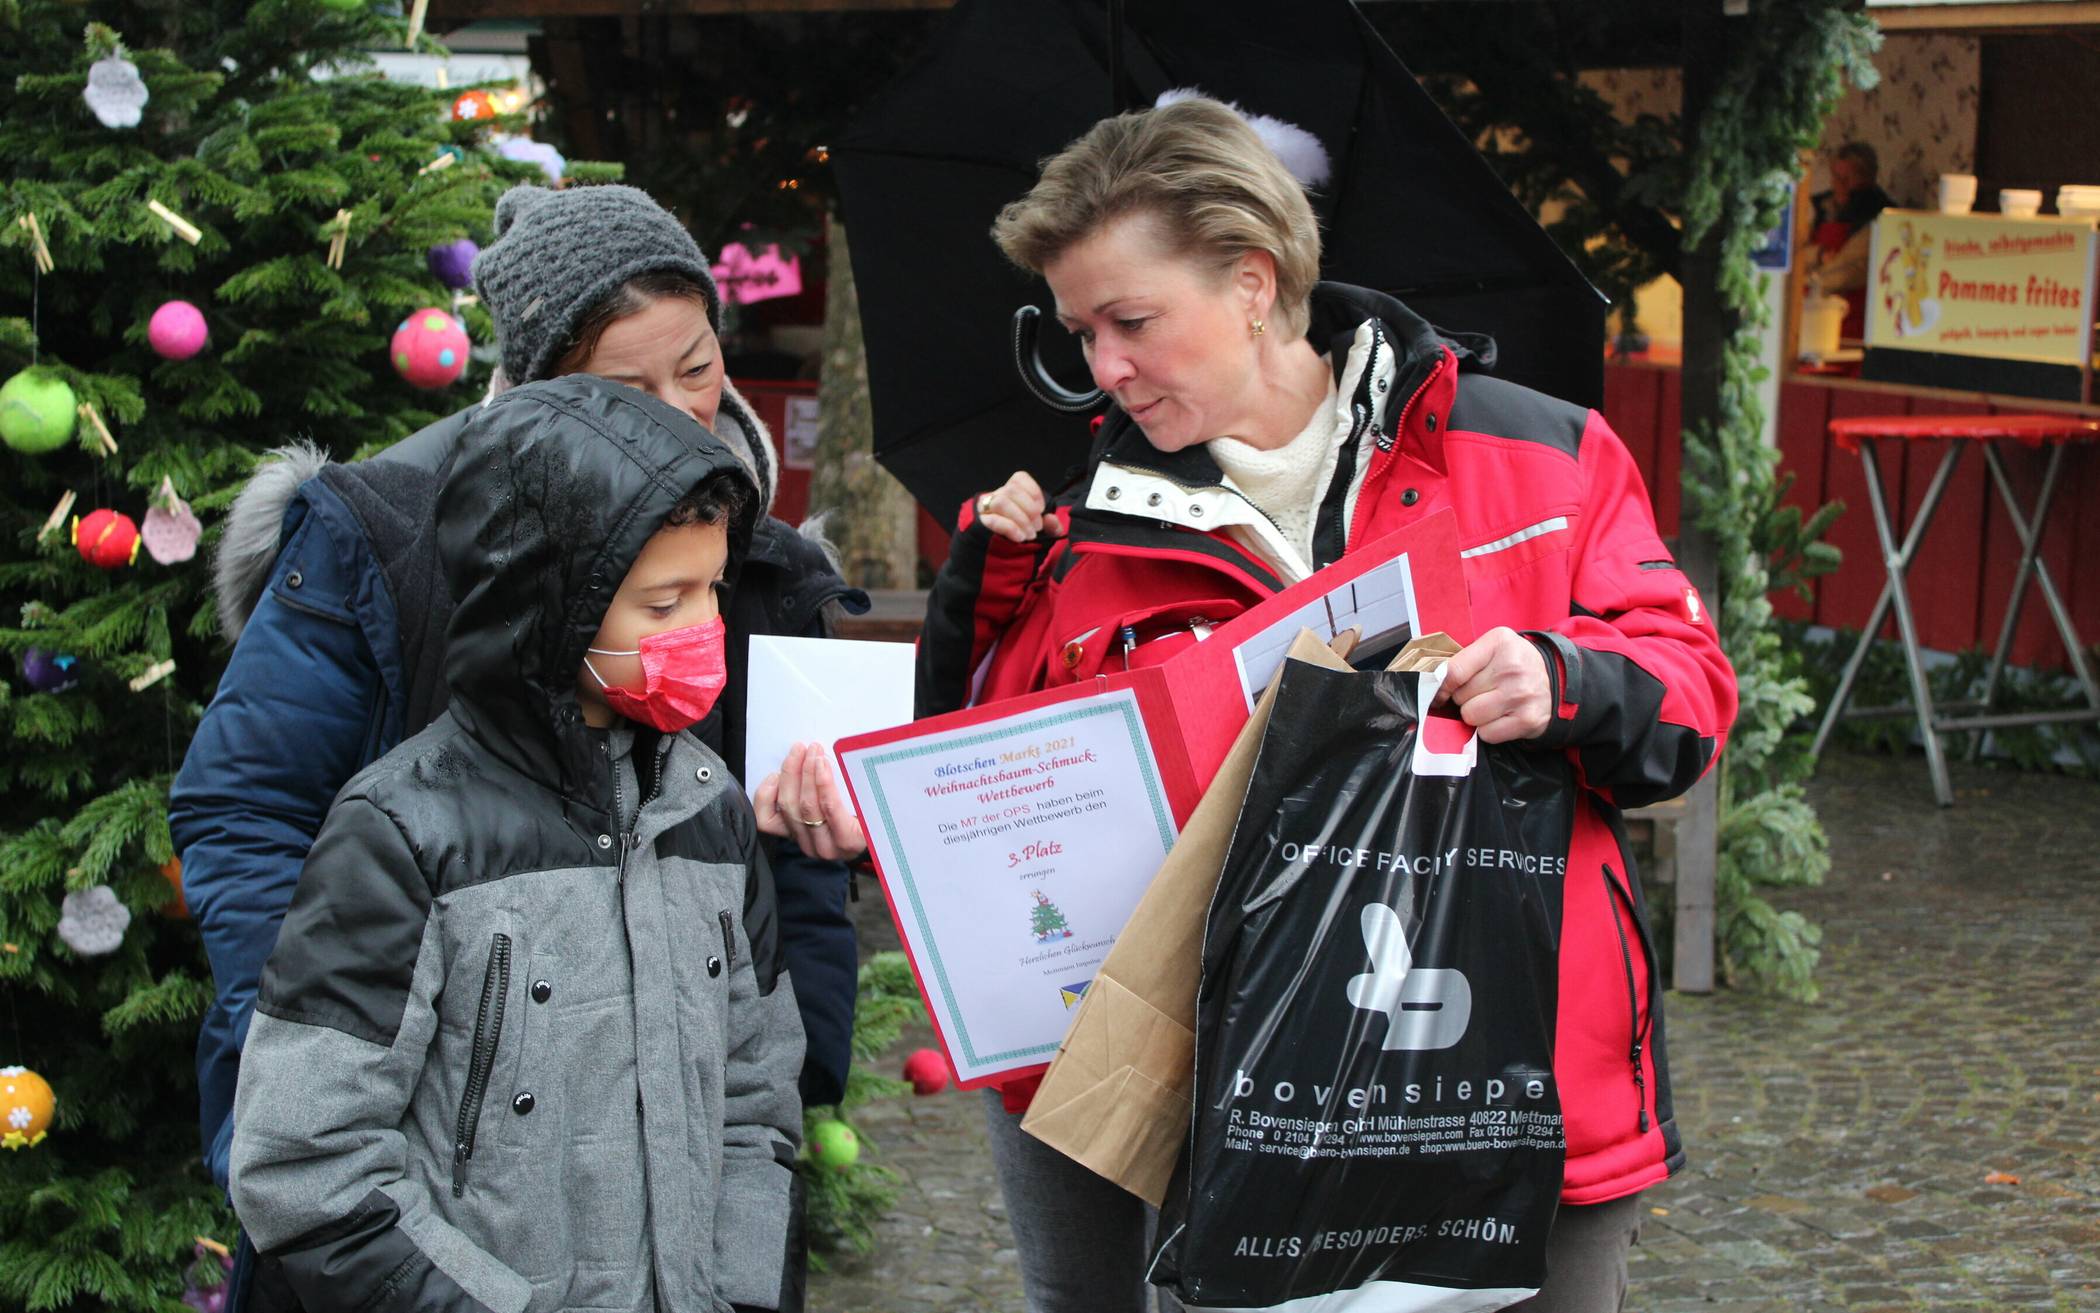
[1867,210,2096,368]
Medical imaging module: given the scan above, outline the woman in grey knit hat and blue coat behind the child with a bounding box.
[170,187,867,1311]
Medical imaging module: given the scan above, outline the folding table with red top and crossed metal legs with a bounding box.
[1814,414,2100,807]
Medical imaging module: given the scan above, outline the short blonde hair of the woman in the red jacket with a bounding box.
[991,97,1319,338]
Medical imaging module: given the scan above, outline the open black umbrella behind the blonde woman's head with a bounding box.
[834,0,1604,521]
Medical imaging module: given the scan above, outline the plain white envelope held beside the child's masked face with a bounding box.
[743,634,914,788]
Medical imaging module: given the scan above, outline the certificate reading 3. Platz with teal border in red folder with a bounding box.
[840,687,1174,1084]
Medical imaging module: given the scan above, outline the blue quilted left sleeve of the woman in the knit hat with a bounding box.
[168,510,386,1187]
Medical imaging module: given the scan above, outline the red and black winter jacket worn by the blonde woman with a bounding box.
[918,284,1737,1204]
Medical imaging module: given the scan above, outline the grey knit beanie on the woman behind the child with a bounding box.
[475,185,722,382]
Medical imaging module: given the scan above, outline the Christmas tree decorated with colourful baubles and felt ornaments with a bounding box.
[0,0,562,1309]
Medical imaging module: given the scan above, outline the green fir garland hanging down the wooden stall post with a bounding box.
[1684,0,1882,1000]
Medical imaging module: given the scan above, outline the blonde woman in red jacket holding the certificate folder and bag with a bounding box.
[918,99,1735,1313]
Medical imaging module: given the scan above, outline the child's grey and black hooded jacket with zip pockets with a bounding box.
[231,376,802,1313]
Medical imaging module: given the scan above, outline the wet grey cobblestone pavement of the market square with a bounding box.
[809,756,2100,1313]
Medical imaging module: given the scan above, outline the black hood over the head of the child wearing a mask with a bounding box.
[437,374,758,800]
